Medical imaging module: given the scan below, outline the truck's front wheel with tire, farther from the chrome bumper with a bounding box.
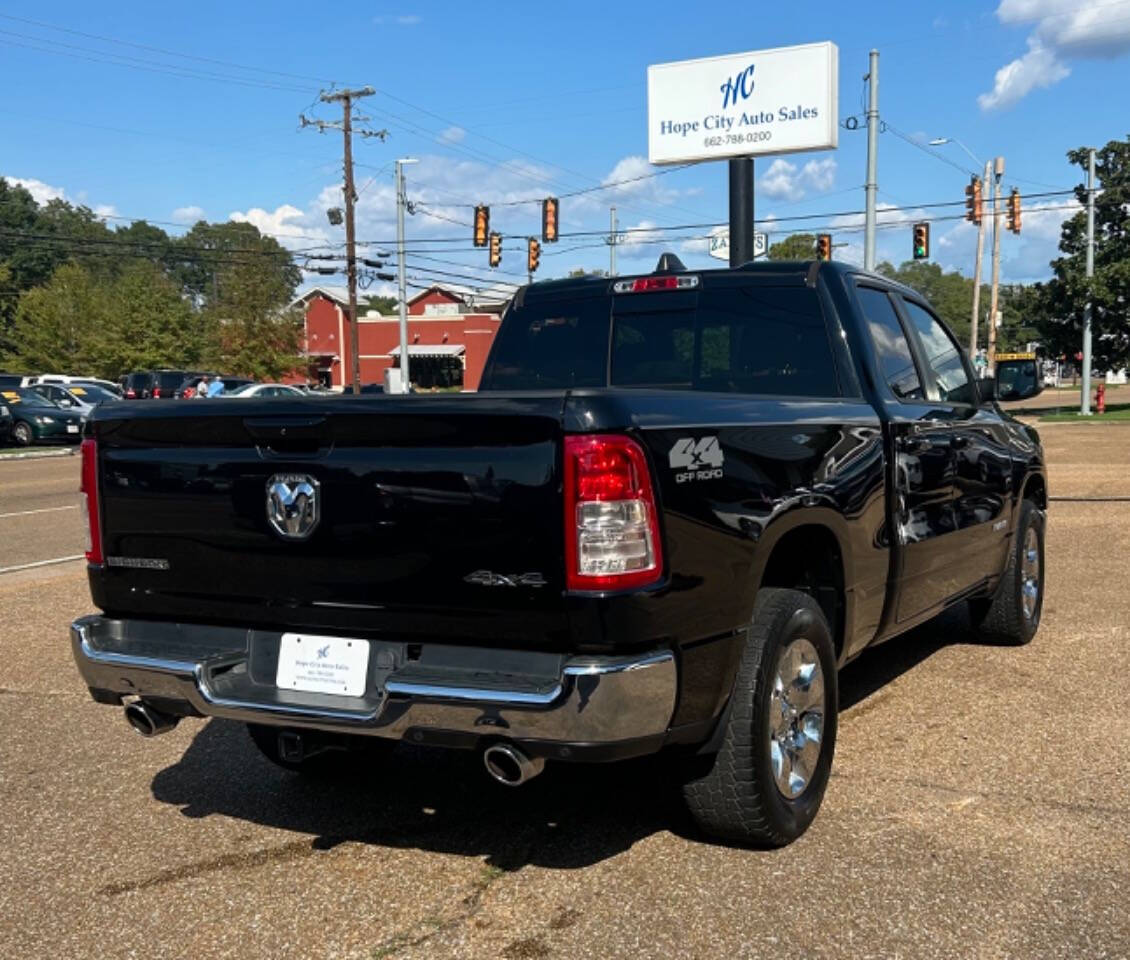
[970,500,1045,646]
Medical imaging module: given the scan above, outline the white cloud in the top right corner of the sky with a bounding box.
[977,0,1130,111]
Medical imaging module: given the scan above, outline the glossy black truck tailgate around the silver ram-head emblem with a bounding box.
[85,393,567,649]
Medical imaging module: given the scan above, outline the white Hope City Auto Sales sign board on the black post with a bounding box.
[647,43,840,164]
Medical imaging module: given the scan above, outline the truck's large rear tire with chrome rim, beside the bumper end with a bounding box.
[683,588,838,847]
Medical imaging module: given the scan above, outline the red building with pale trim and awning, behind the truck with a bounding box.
[288,285,505,390]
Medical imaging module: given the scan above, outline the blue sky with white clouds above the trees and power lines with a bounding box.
[0,0,1130,289]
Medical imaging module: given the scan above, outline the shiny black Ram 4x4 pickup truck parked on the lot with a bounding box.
[72,260,1048,845]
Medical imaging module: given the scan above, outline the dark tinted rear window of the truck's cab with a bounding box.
[480,277,842,398]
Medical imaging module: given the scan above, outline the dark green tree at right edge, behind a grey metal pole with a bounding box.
[1025,137,1130,370]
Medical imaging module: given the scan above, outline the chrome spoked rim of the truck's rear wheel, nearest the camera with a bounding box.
[770,637,825,800]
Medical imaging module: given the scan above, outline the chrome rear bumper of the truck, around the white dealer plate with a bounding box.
[71,616,678,745]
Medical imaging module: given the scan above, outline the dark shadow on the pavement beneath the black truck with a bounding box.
[151,611,1007,871]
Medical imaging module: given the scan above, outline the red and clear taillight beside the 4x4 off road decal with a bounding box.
[565,435,663,590]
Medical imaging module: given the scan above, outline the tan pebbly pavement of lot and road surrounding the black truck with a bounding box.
[0,424,1130,958]
